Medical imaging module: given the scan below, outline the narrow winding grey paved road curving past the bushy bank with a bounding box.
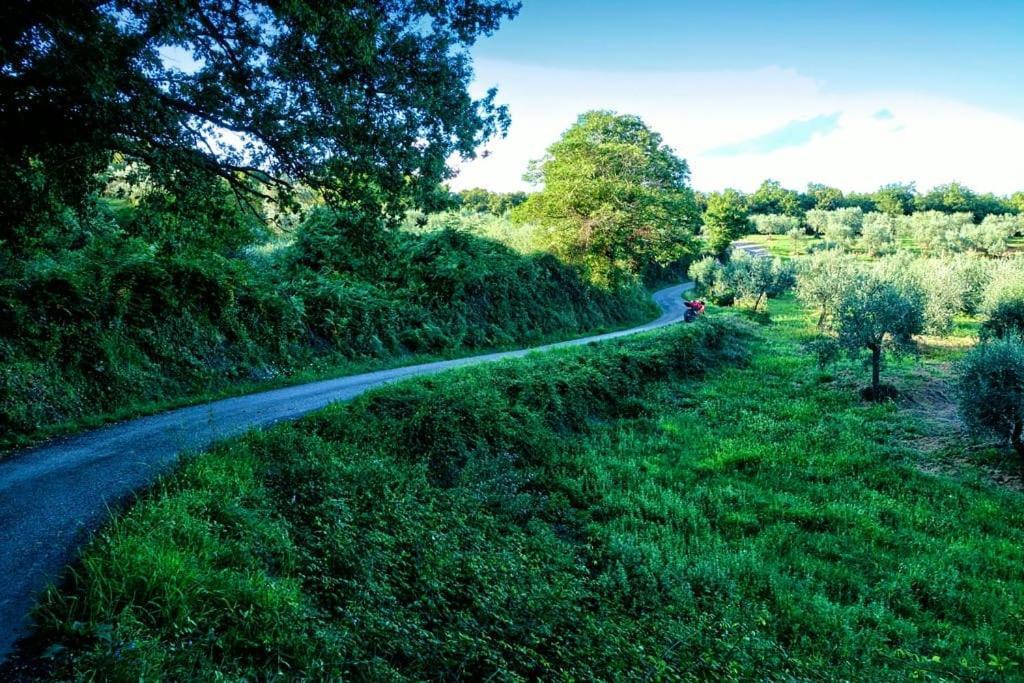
[0,283,692,660]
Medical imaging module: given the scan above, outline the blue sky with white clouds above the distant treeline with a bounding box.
[451,0,1024,194]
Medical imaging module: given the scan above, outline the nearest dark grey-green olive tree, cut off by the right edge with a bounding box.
[957,335,1024,458]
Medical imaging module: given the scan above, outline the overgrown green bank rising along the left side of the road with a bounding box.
[0,224,657,458]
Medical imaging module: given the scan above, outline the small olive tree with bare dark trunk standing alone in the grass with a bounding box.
[827,270,925,399]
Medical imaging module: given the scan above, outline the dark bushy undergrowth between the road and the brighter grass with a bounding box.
[22,319,745,680]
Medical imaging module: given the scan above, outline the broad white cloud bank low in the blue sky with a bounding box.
[453,60,1024,194]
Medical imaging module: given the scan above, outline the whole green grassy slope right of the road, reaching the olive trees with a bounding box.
[9,300,1024,680]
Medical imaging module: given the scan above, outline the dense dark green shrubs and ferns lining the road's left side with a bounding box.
[0,208,651,441]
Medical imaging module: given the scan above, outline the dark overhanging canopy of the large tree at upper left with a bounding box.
[0,0,518,232]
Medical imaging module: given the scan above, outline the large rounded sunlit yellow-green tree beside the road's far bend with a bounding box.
[513,112,697,282]
